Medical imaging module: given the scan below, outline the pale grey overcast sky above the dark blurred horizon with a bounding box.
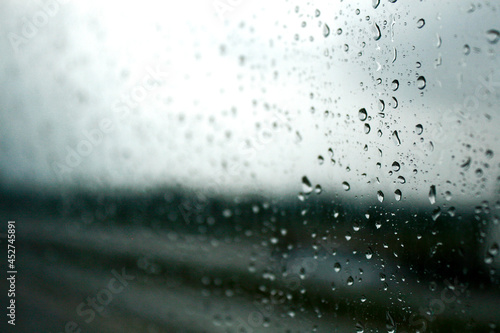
[0,0,500,208]
